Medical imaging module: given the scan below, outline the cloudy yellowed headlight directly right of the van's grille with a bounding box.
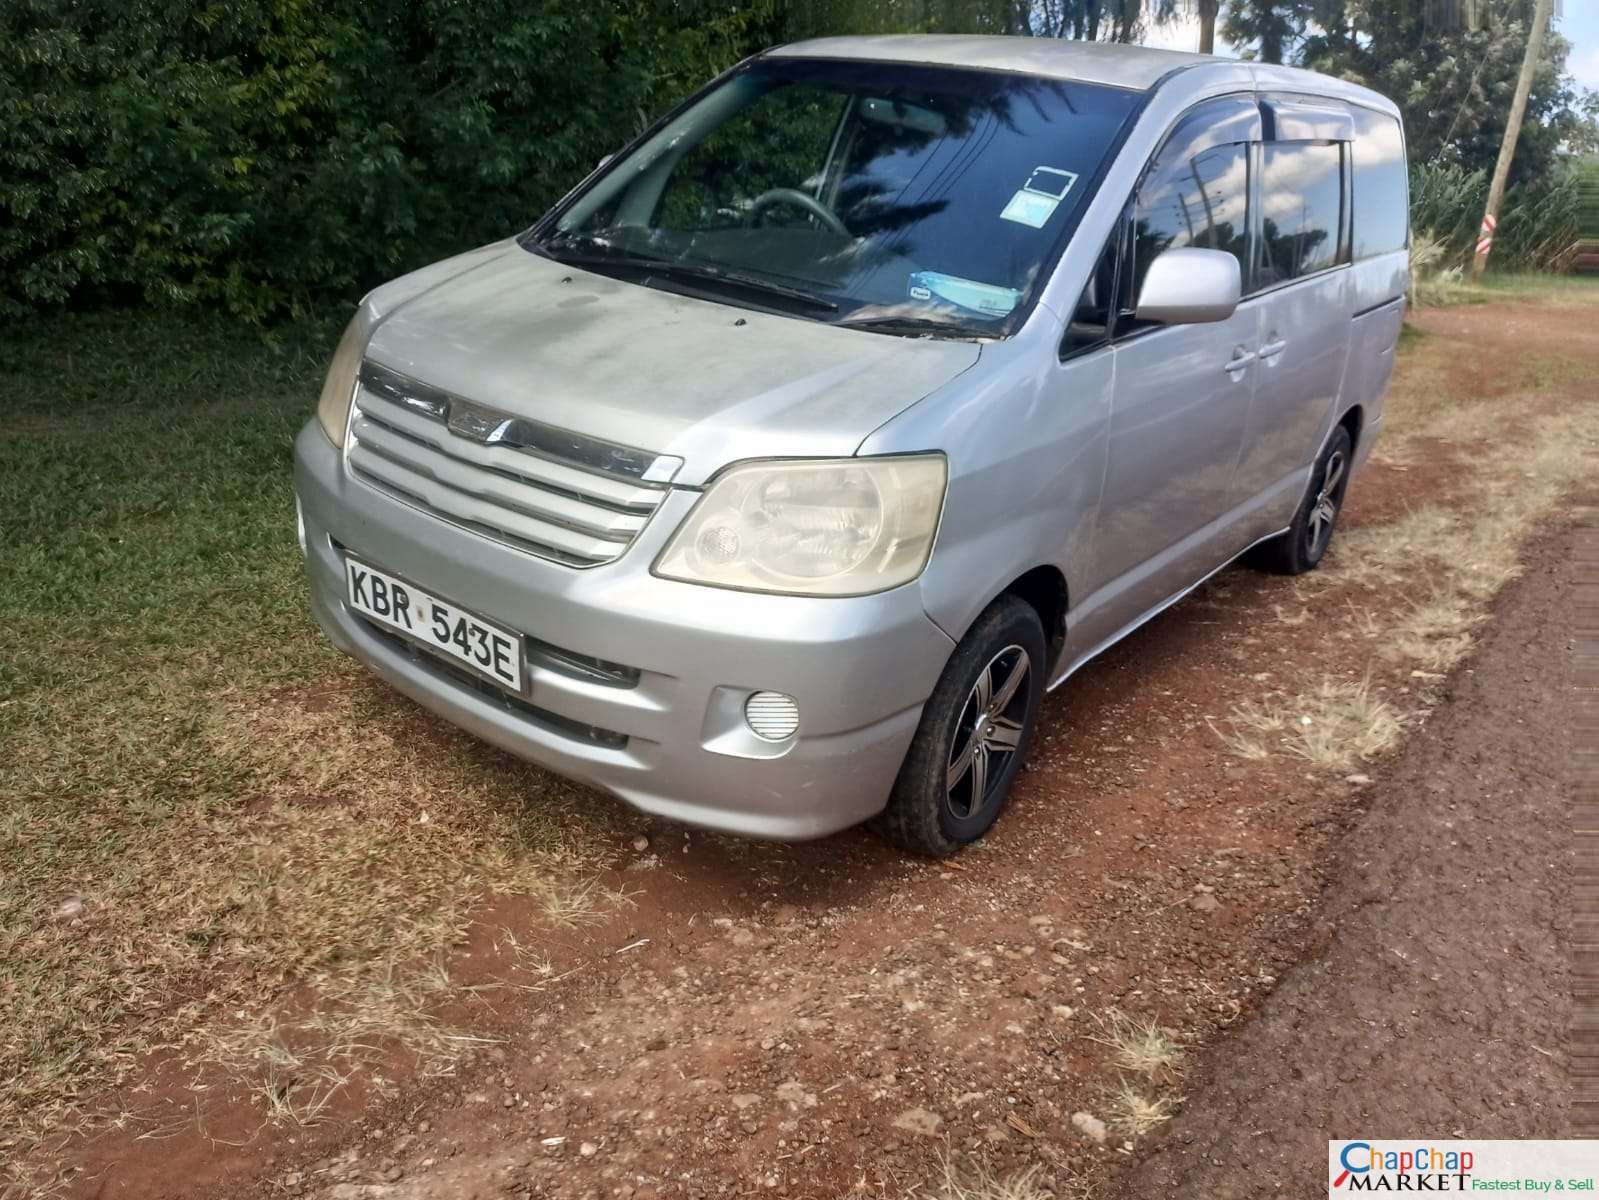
[656,454,947,595]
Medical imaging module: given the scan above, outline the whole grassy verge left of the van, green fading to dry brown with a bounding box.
[0,312,609,1190]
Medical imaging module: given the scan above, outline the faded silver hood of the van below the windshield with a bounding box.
[366,242,979,485]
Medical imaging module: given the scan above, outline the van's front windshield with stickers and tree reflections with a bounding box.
[528,59,1137,336]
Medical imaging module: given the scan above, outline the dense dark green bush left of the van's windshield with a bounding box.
[0,0,786,318]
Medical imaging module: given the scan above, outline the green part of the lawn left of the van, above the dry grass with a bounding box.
[0,318,343,681]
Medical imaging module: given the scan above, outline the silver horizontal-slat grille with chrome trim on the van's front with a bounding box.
[345,362,681,566]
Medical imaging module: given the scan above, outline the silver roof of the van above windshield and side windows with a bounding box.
[768,34,1398,112]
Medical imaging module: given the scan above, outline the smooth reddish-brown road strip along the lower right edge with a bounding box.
[1118,515,1593,1200]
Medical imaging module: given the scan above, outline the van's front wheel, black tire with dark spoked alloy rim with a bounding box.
[876,595,1046,858]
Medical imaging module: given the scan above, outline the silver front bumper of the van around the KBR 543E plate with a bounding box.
[294,421,953,838]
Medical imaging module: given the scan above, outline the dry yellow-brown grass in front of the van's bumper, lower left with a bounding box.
[0,668,625,1179]
